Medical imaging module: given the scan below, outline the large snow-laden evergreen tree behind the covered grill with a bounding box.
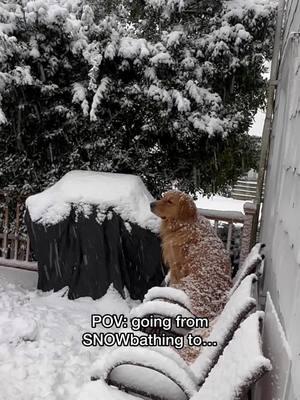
[0,0,275,195]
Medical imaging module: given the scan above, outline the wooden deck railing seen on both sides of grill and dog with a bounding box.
[0,192,256,270]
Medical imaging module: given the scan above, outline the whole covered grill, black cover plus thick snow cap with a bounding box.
[25,171,164,299]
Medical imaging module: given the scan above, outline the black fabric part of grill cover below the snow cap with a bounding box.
[25,205,165,299]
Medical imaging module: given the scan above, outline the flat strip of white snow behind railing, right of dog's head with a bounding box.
[196,194,246,212]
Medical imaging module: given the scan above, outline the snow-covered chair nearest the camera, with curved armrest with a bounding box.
[98,311,271,400]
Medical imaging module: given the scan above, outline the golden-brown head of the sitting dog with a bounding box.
[150,190,197,222]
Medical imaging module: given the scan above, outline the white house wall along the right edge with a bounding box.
[256,0,300,400]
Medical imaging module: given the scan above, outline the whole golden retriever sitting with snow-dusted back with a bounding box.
[150,190,231,321]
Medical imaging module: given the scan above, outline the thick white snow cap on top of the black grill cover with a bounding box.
[26,171,159,232]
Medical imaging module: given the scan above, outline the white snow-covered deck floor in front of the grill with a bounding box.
[0,267,138,400]
